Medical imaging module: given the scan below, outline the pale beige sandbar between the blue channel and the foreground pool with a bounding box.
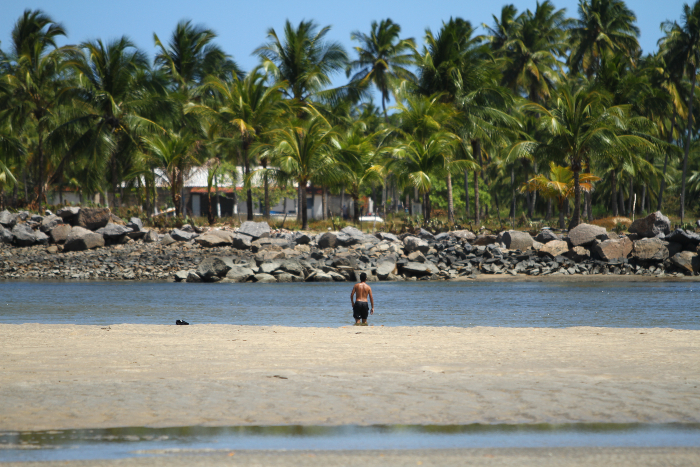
[0,326,700,431]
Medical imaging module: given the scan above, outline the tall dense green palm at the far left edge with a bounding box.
[0,10,70,210]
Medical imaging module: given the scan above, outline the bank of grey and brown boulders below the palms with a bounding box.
[0,208,700,283]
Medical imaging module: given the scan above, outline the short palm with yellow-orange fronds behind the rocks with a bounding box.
[520,162,600,229]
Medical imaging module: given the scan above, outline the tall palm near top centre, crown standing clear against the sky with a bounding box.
[347,18,415,119]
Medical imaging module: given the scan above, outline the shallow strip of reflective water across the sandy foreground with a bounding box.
[0,423,700,462]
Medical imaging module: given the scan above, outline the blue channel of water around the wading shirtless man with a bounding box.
[0,282,700,329]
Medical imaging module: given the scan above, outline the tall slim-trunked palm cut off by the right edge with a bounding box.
[660,0,700,223]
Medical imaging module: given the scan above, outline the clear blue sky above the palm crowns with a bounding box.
[0,0,686,80]
